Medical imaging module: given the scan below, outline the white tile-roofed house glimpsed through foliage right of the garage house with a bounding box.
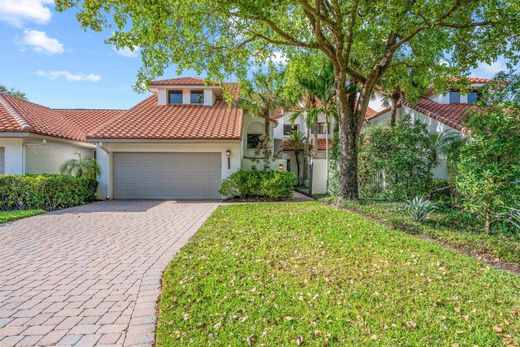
[274,77,491,194]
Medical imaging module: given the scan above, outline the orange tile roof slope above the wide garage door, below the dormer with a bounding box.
[87,95,242,140]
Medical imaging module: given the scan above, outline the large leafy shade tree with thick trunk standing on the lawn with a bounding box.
[56,0,520,199]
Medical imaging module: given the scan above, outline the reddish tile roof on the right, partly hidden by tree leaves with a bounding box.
[405,98,475,130]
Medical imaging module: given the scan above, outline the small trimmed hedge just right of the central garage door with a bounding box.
[219,170,296,200]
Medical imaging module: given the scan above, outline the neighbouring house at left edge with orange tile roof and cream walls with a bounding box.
[0,93,120,175]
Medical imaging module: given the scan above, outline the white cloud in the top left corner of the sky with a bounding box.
[0,0,54,27]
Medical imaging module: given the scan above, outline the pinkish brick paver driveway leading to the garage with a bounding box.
[0,201,218,347]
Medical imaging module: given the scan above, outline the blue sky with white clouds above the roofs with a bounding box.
[0,0,505,108]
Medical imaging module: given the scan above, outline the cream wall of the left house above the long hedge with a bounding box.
[25,140,94,174]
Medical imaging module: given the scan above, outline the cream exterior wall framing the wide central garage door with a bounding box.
[94,141,241,199]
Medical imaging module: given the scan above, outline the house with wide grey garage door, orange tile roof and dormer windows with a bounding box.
[87,78,279,199]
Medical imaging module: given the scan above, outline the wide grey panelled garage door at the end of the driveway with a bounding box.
[113,153,221,199]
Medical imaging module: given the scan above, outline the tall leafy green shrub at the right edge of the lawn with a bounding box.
[456,108,520,232]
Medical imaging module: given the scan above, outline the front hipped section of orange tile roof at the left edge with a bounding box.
[0,93,85,141]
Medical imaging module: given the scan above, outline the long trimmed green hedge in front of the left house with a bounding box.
[0,175,97,211]
